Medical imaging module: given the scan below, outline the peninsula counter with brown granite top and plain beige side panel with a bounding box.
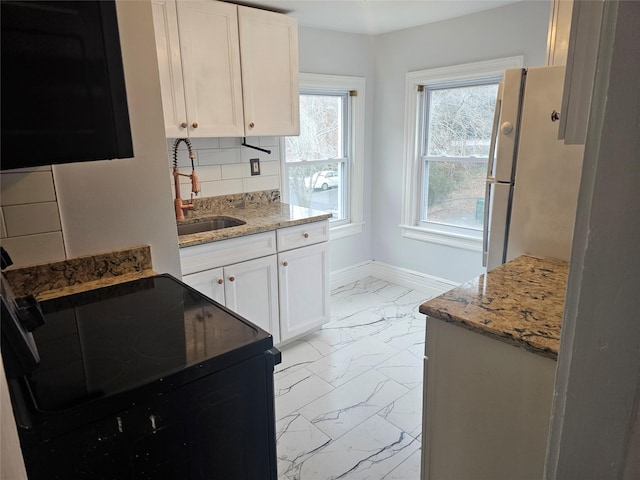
[419,255,568,480]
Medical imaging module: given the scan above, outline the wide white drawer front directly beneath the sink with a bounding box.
[180,232,276,275]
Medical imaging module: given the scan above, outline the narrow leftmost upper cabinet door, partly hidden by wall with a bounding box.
[152,0,188,138]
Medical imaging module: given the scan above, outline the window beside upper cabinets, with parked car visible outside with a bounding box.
[282,74,364,238]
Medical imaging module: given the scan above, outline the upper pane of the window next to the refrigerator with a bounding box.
[427,84,498,158]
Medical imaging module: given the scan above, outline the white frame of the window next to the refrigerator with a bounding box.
[400,55,523,252]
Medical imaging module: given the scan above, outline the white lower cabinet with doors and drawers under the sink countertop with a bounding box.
[180,221,330,343]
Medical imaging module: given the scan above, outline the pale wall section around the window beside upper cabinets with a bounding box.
[298,27,375,271]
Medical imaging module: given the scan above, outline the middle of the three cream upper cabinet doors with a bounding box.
[177,1,244,137]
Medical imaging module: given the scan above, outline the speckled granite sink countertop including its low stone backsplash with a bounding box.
[178,192,331,248]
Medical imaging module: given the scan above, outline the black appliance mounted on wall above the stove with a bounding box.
[0,0,133,170]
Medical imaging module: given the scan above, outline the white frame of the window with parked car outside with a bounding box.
[280,73,366,240]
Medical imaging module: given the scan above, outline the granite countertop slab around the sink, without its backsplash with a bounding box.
[178,202,332,248]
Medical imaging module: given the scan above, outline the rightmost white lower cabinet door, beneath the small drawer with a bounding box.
[278,242,330,341]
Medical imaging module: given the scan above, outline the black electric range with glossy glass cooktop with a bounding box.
[5,274,279,479]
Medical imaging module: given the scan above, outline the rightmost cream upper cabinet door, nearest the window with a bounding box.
[238,6,300,136]
